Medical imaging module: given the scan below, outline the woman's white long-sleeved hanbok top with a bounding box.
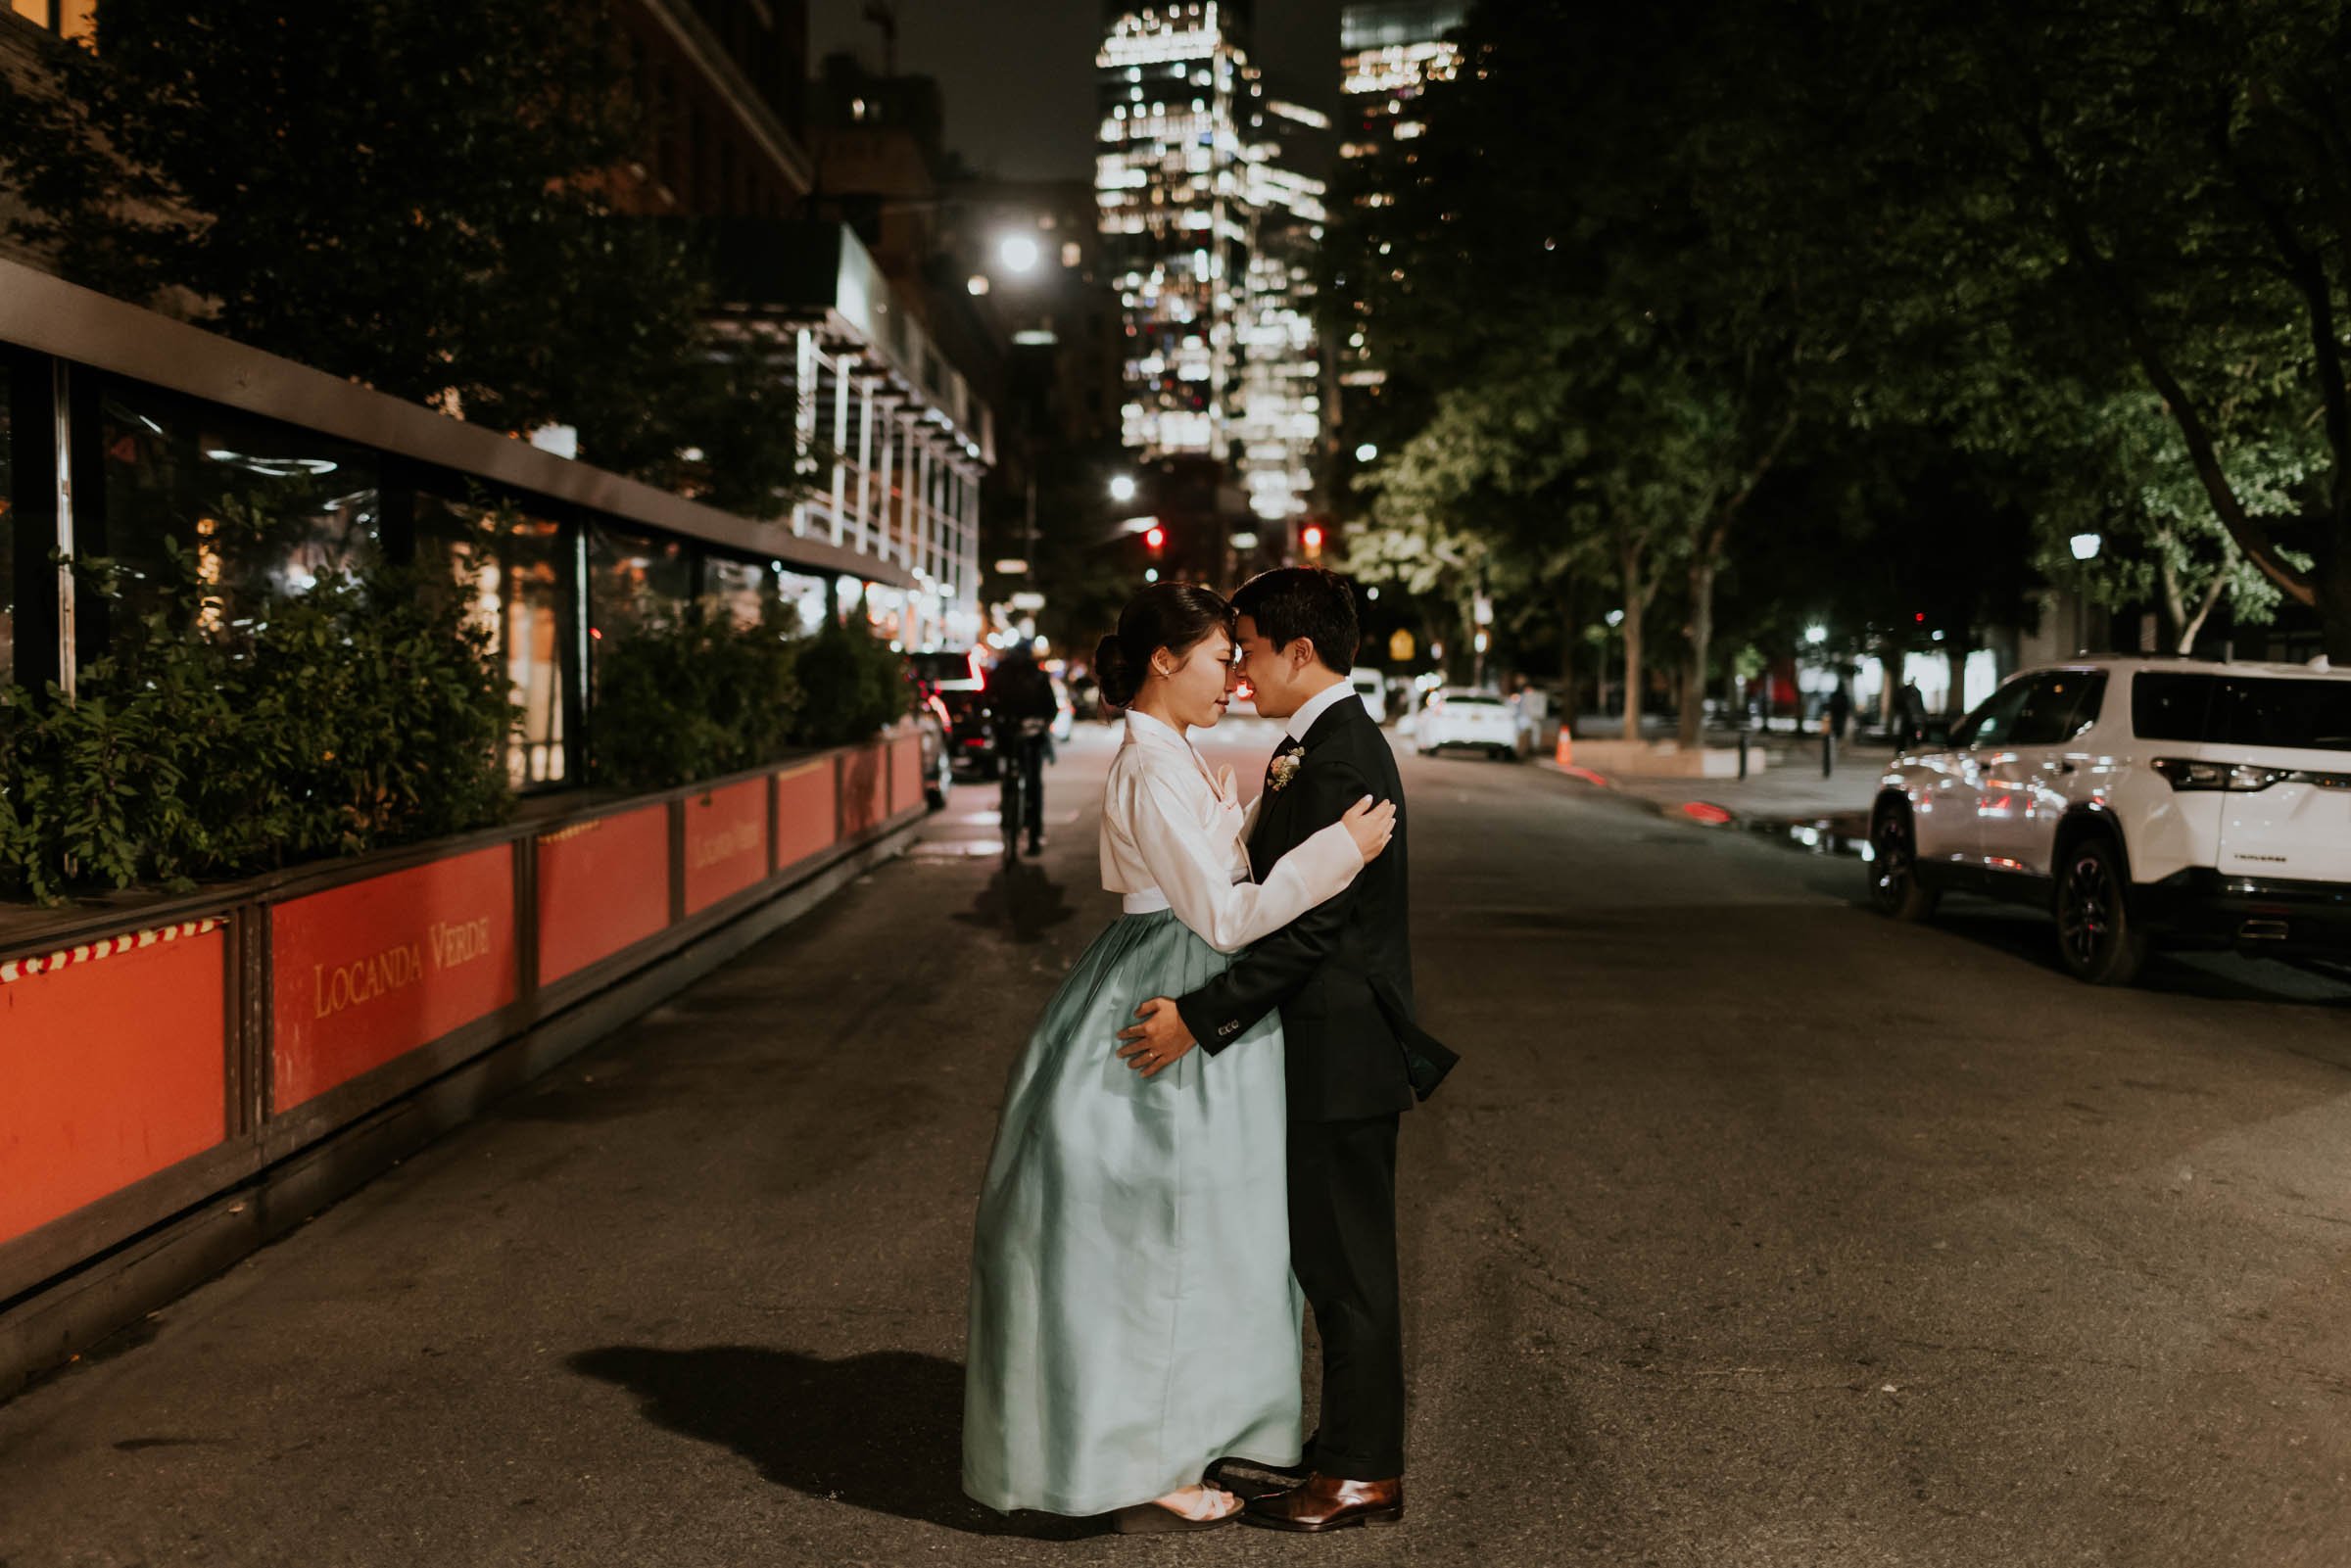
[1103,707,1364,952]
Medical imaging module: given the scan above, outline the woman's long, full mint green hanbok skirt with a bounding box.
[964,910,1303,1514]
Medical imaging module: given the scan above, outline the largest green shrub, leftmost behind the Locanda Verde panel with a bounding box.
[0,517,515,903]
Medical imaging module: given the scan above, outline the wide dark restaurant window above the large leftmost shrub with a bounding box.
[99,383,383,637]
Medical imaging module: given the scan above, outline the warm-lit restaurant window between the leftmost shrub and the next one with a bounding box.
[416,494,571,790]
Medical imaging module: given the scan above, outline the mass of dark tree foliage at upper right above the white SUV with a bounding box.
[1326,0,2351,734]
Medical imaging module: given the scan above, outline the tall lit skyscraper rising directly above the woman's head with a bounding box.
[1095,0,1258,458]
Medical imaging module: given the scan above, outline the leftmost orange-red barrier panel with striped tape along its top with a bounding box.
[0,920,228,1241]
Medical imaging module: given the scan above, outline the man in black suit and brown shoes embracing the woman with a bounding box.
[1119,566,1453,1531]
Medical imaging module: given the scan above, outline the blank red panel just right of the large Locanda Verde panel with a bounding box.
[539,806,670,985]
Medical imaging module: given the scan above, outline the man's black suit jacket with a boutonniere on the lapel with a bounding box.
[1176,695,1456,1121]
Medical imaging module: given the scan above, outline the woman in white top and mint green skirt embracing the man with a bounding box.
[964,583,1397,1533]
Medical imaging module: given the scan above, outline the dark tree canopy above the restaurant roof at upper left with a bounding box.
[0,0,797,515]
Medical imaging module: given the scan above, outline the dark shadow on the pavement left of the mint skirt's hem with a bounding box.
[569,1345,1103,1540]
